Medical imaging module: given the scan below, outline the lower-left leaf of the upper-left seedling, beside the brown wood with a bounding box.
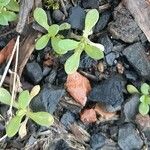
[35,34,50,50]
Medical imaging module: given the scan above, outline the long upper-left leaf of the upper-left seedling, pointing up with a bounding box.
[33,8,49,31]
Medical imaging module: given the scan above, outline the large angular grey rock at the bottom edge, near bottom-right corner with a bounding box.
[118,123,143,150]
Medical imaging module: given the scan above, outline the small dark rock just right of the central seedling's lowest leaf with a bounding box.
[79,54,97,69]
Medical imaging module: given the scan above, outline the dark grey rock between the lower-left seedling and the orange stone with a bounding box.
[31,86,65,114]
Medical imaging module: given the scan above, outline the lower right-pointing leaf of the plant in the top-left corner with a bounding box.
[1,11,17,21]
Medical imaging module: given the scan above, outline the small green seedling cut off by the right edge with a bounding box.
[127,83,150,115]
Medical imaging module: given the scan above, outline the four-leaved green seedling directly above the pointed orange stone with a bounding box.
[58,9,104,74]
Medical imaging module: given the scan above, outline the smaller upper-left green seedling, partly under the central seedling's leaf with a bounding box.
[34,8,70,53]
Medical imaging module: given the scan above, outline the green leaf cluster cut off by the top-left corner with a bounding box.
[0,0,19,25]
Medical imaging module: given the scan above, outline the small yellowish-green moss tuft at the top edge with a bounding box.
[44,0,59,9]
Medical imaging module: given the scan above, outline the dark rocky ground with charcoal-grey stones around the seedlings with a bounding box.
[0,0,150,150]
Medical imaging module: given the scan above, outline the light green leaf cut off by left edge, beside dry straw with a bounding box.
[0,88,11,105]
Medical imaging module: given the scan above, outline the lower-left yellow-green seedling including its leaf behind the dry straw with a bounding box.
[0,85,54,137]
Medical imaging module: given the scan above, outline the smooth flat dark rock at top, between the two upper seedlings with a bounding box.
[68,6,85,30]
